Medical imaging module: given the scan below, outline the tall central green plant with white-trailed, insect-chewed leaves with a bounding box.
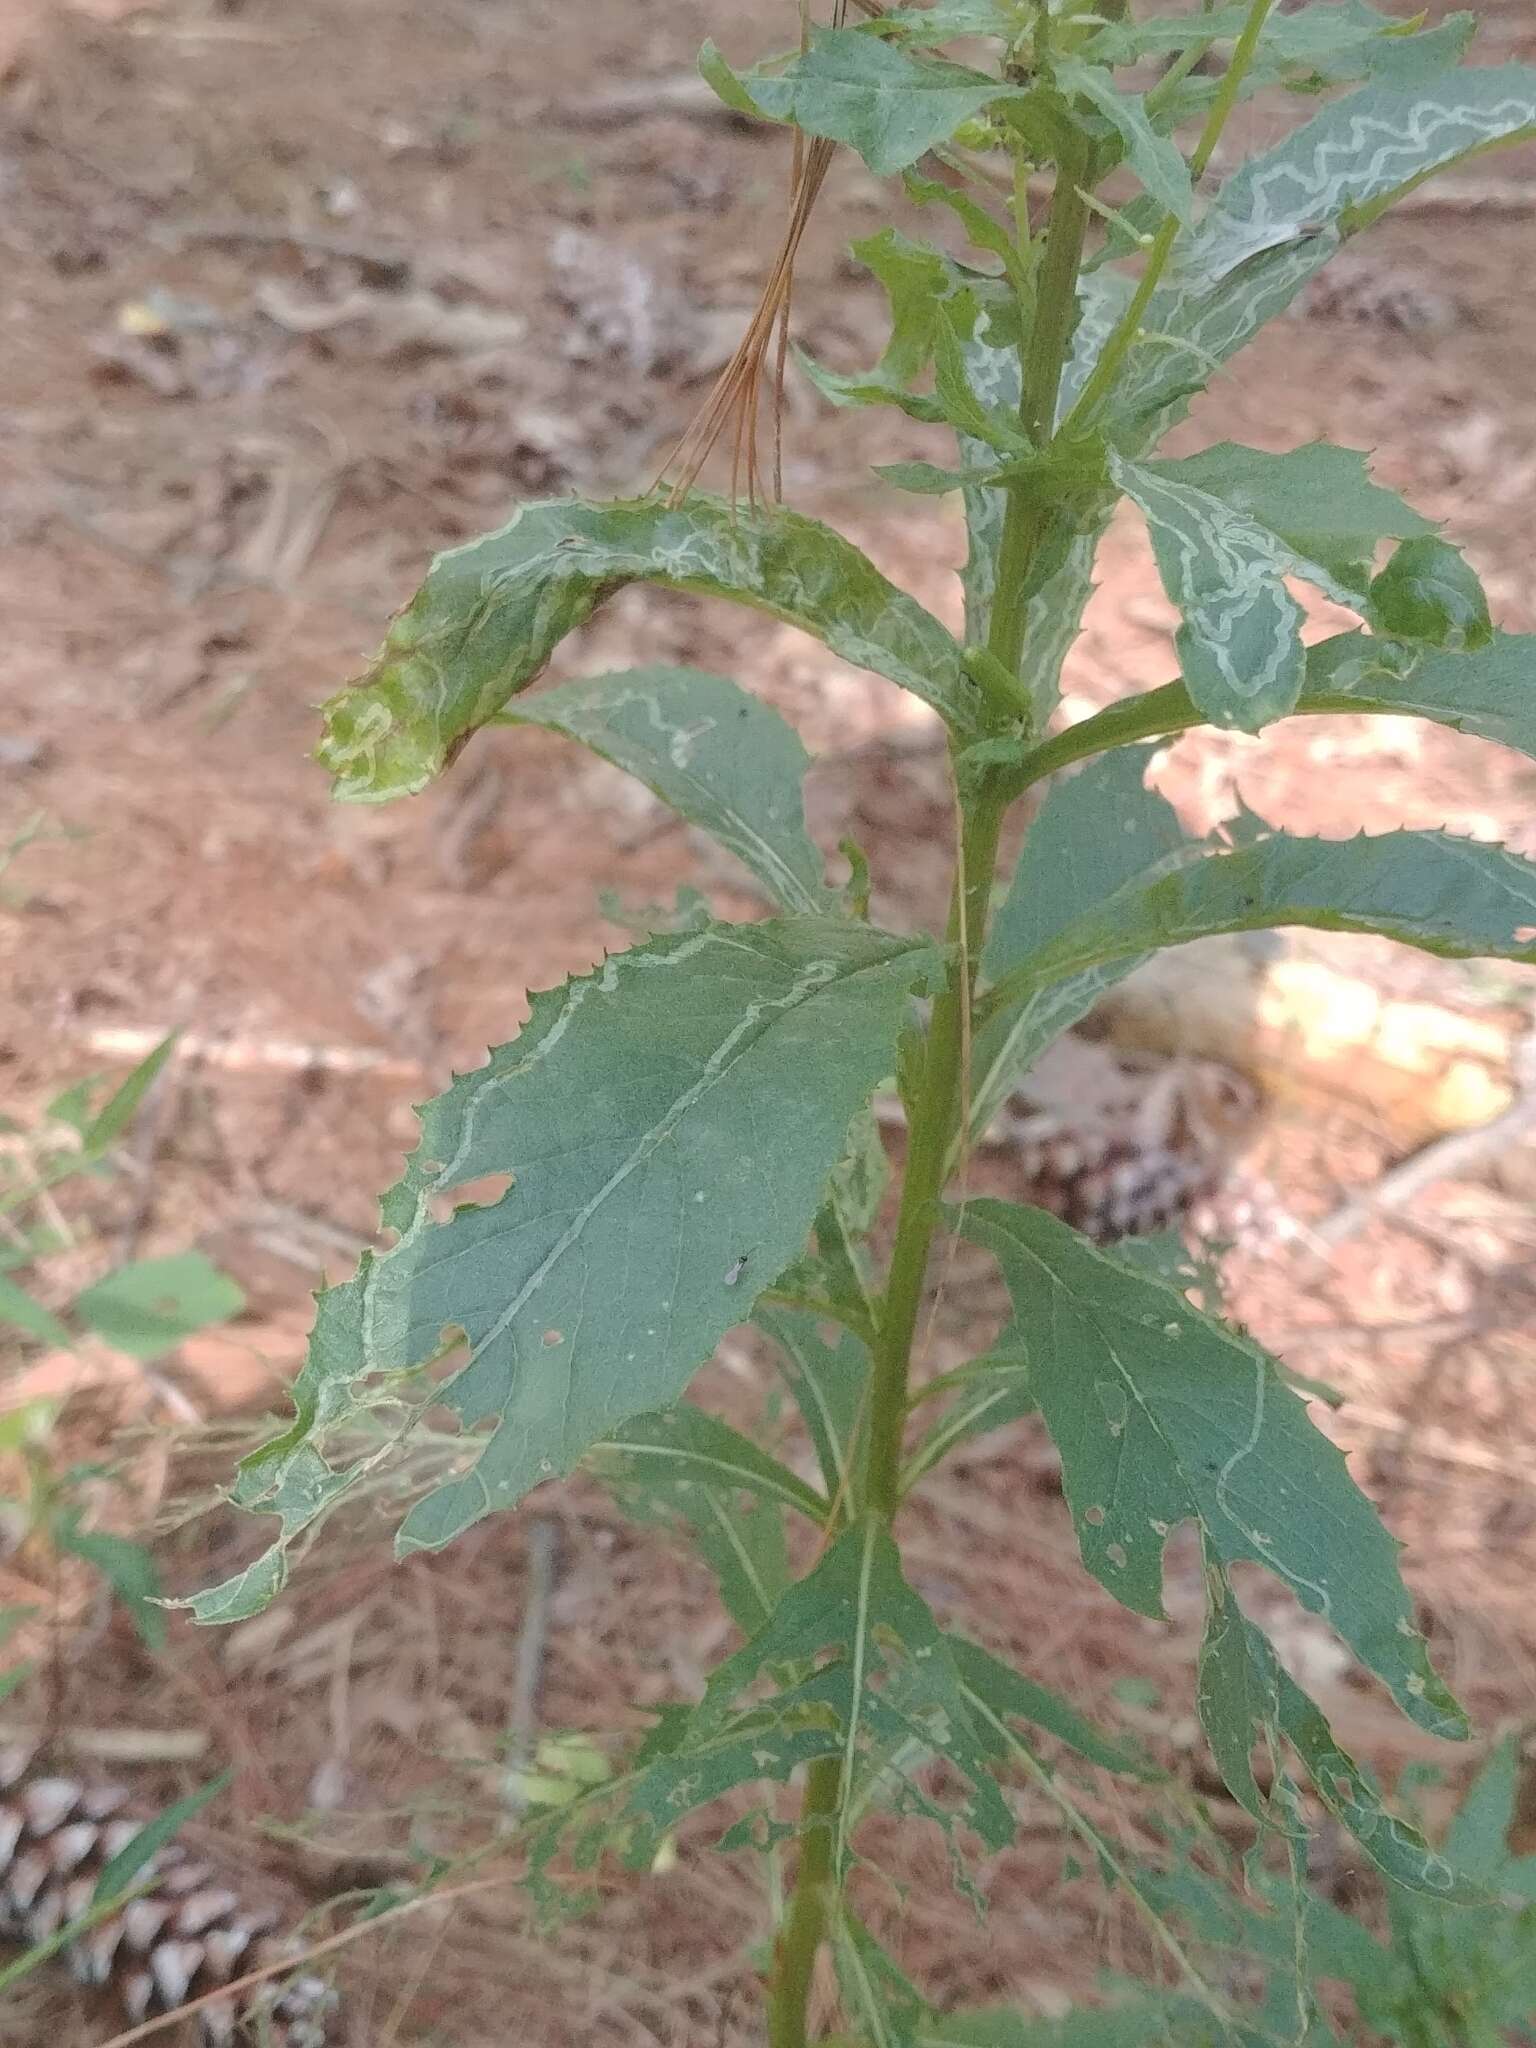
[190,0,1536,2048]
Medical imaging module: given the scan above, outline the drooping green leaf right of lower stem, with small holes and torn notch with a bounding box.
[956,1200,1466,1735]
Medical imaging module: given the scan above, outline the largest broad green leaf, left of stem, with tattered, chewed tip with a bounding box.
[195,918,936,1620]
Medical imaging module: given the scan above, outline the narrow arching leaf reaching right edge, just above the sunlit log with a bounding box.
[983,821,1536,1016]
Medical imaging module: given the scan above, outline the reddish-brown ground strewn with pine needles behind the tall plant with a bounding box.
[0,0,1536,2048]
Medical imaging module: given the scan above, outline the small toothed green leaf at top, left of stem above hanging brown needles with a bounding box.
[698,29,1010,178]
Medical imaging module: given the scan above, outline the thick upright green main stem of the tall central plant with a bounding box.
[768,48,1114,2048]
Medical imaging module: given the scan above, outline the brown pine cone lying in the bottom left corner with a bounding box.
[0,1749,338,2048]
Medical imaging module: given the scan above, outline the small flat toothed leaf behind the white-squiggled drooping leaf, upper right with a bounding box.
[1147,440,1436,598]
